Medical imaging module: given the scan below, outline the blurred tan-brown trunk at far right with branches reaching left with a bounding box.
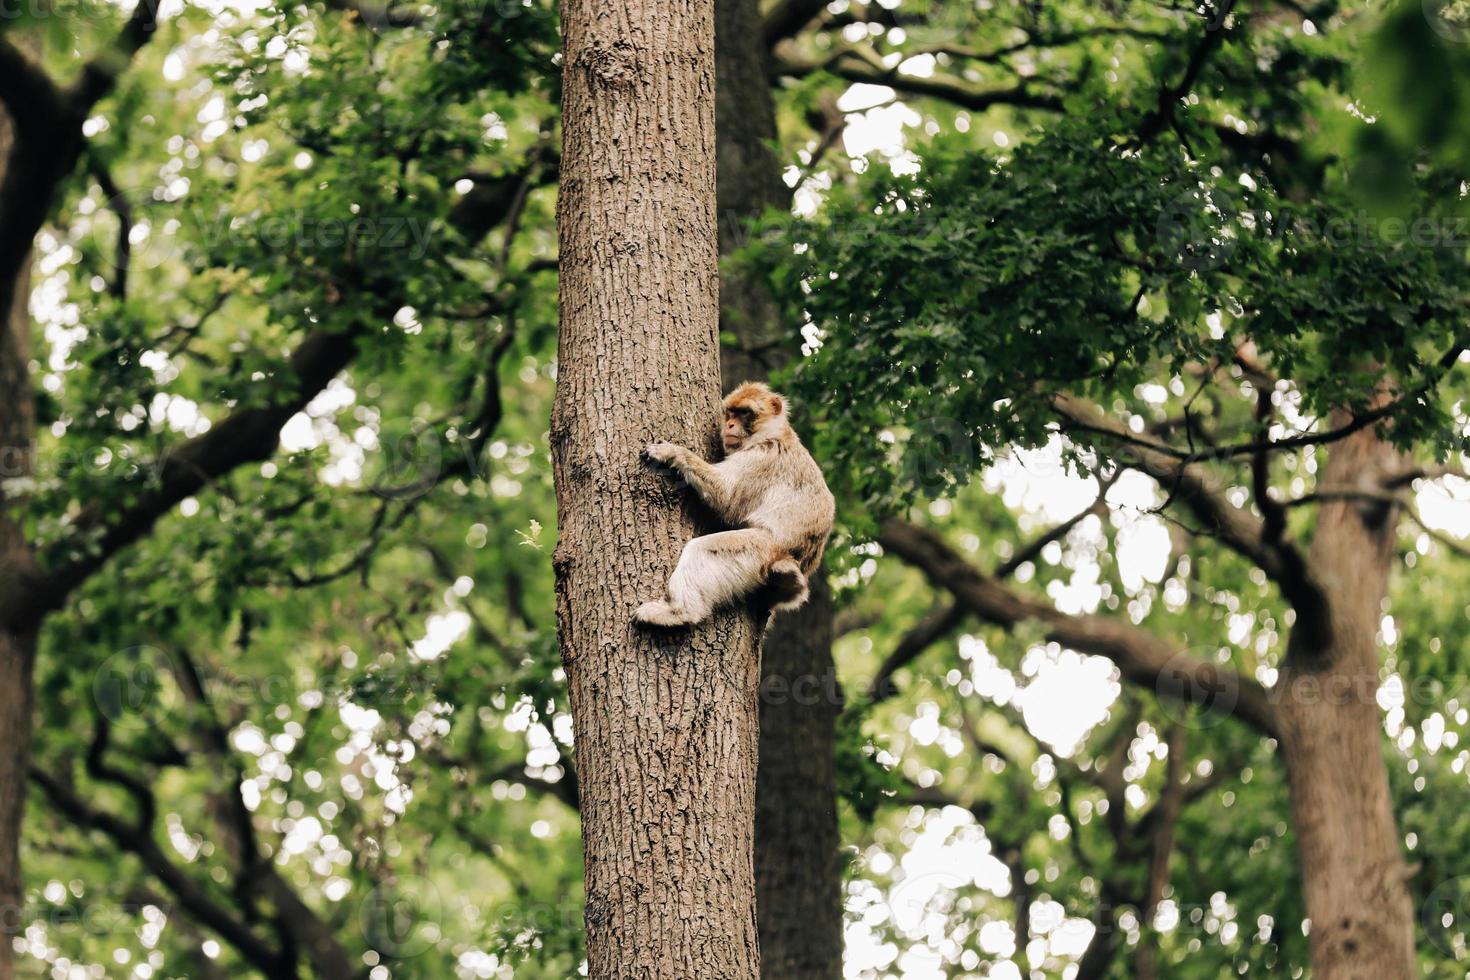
[1276,429,1416,980]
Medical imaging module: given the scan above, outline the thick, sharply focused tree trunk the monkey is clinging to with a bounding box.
[551,0,760,980]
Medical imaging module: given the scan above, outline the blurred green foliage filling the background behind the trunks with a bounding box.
[7,0,1470,980]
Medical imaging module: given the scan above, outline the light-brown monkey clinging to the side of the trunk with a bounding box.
[634,382,836,627]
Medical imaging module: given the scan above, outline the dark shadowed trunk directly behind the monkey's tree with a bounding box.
[714,0,842,980]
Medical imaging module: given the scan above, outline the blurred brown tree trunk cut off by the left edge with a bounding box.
[0,97,35,980]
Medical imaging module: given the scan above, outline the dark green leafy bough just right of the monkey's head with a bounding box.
[754,113,1466,510]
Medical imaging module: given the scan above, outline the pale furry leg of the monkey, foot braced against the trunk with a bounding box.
[634,527,775,626]
